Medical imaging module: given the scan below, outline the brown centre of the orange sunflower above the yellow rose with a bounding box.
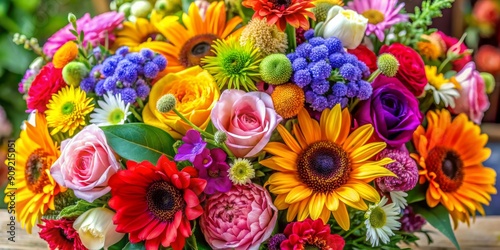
[179,34,219,68]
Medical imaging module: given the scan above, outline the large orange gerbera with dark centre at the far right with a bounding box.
[411,110,497,227]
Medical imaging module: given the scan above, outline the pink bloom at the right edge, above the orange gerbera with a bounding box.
[453,62,490,124]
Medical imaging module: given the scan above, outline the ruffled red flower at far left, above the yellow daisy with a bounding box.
[27,63,66,113]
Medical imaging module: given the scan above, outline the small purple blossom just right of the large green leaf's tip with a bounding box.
[174,129,207,162]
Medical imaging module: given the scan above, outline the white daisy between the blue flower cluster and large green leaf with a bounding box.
[90,92,131,126]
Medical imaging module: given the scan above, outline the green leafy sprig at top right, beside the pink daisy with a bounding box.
[391,0,455,45]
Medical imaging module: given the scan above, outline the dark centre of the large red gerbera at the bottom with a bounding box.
[146,181,185,222]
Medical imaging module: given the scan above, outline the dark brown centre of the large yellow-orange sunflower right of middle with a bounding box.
[297,141,351,193]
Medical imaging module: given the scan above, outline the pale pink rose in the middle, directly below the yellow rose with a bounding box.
[211,89,282,157]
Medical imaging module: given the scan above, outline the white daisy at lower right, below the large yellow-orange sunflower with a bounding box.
[365,196,401,247]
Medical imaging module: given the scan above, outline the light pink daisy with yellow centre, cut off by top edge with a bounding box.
[347,0,408,41]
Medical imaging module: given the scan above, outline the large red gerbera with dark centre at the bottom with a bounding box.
[109,156,207,250]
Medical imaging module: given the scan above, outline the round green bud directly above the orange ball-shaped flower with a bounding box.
[260,54,292,85]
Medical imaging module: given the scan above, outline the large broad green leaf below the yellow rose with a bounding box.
[102,123,175,164]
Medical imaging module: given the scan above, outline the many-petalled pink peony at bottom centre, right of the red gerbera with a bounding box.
[200,183,278,250]
